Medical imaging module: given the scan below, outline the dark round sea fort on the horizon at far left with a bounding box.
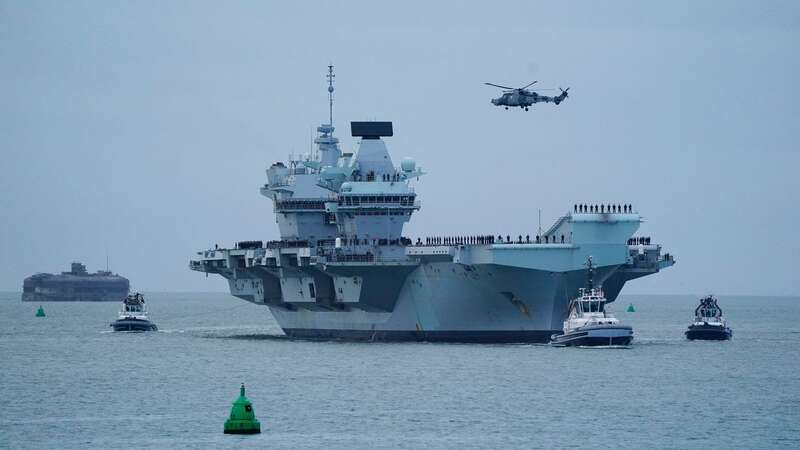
[22,262,130,302]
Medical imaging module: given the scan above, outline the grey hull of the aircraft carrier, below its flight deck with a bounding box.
[197,240,673,343]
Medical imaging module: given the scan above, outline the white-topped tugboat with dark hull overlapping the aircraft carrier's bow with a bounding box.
[550,256,633,347]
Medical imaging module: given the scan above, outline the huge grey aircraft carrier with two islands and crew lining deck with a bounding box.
[189,67,674,342]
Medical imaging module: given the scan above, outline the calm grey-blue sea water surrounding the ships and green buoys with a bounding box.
[0,293,800,449]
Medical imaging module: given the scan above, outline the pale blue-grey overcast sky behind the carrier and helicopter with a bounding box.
[0,0,800,295]
